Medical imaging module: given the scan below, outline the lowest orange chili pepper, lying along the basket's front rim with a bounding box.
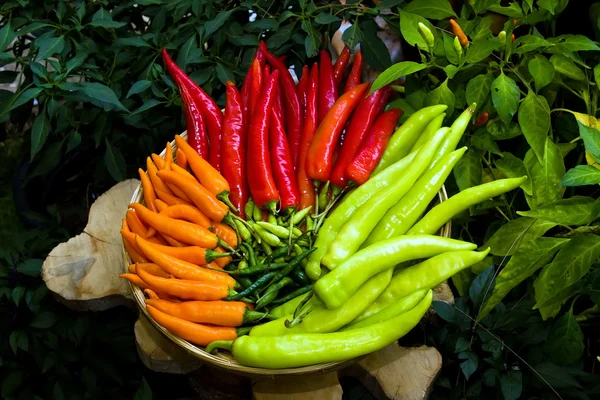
[146,305,238,346]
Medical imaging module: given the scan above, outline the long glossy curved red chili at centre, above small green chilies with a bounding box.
[247,71,279,212]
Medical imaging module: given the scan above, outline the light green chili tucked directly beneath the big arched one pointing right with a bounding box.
[369,247,490,311]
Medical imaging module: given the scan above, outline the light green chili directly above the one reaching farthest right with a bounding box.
[365,147,467,246]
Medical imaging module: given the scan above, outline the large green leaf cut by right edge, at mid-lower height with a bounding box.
[533,235,600,308]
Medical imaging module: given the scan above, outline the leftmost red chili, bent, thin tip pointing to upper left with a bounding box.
[162,49,223,170]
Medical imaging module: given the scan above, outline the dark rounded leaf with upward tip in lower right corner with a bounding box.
[545,309,584,365]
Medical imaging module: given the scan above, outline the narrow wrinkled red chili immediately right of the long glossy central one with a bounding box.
[269,89,300,211]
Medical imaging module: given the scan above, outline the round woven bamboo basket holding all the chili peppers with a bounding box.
[122,131,451,377]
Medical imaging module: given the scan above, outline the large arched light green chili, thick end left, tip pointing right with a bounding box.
[315,235,477,309]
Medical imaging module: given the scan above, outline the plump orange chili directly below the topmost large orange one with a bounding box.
[158,170,229,221]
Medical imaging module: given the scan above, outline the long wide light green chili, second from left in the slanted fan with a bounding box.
[321,128,450,269]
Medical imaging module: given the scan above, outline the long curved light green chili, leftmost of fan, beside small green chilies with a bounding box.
[305,148,416,281]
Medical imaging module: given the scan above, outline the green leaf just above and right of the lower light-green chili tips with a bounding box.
[485,217,556,256]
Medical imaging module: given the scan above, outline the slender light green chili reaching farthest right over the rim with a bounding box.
[407,176,527,235]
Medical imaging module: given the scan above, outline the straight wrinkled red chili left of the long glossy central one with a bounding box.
[221,81,248,218]
